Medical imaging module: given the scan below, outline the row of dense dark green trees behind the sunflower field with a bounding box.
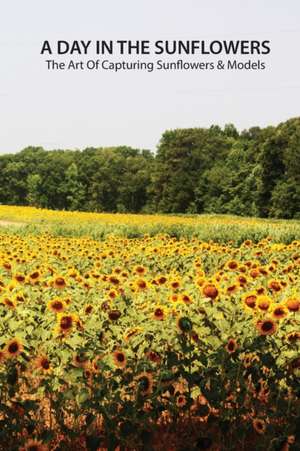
[0,118,300,218]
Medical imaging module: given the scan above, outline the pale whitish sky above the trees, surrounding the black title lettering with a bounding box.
[0,0,300,153]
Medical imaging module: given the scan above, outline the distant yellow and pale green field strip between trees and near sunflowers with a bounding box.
[0,205,300,244]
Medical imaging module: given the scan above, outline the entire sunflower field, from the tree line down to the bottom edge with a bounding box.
[0,206,300,451]
